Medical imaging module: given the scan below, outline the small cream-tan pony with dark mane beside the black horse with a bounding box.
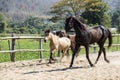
[45,29,71,63]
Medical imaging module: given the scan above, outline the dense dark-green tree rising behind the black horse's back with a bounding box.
[81,0,110,25]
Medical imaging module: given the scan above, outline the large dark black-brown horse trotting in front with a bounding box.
[65,17,112,67]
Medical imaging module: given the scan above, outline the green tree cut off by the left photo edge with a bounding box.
[0,13,7,33]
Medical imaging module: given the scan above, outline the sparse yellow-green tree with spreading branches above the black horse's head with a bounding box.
[50,0,86,21]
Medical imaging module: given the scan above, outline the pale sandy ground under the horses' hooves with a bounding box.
[0,52,120,80]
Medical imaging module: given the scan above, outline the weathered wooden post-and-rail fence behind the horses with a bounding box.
[0,34,120,62]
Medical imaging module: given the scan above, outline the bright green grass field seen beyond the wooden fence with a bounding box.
[0,37,120,62]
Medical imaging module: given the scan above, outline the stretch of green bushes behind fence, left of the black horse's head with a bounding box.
[6,17,63,35]
